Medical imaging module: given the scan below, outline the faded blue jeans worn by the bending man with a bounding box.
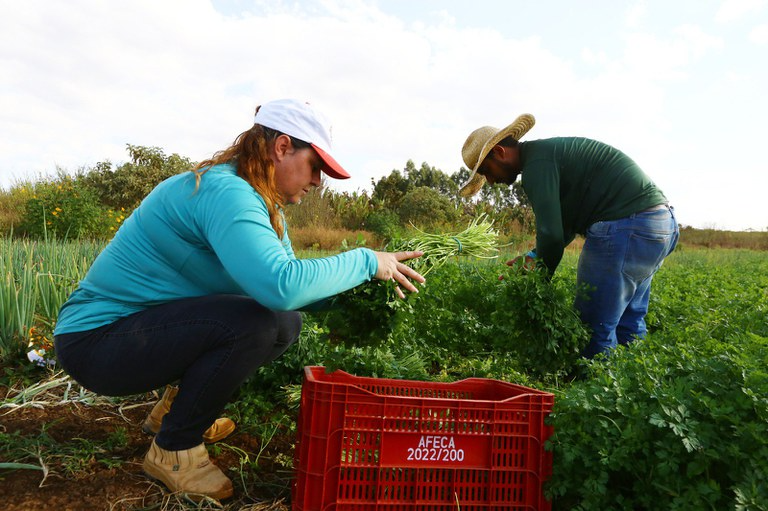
[575,207,680,358]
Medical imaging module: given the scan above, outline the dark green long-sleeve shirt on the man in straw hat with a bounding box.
[519,137,667,272]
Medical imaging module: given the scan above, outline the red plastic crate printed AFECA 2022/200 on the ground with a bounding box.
[292,366,554,511]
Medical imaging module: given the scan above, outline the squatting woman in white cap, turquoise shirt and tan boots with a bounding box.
[54,99,424,499]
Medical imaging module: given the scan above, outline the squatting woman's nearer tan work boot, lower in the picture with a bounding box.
[144,440,232,502]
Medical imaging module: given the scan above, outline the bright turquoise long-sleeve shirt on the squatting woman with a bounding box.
[55,165,378,334]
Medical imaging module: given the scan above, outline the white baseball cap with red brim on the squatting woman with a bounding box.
[254,99,350,179]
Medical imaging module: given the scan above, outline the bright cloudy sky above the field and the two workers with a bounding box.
[0,0,768,230]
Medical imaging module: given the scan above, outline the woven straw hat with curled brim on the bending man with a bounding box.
[459,114,536,197]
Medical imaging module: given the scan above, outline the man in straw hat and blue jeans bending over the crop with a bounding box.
[460,114,679,358]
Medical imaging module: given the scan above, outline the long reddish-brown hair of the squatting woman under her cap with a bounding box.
[192,124,285,239]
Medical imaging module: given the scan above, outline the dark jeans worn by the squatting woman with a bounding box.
[54,295,301,450]
